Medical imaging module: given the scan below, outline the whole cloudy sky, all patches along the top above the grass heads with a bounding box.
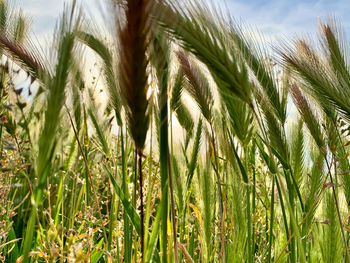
[15,0,350,43]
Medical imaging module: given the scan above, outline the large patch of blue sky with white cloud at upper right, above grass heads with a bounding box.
[218,0,350,39]
